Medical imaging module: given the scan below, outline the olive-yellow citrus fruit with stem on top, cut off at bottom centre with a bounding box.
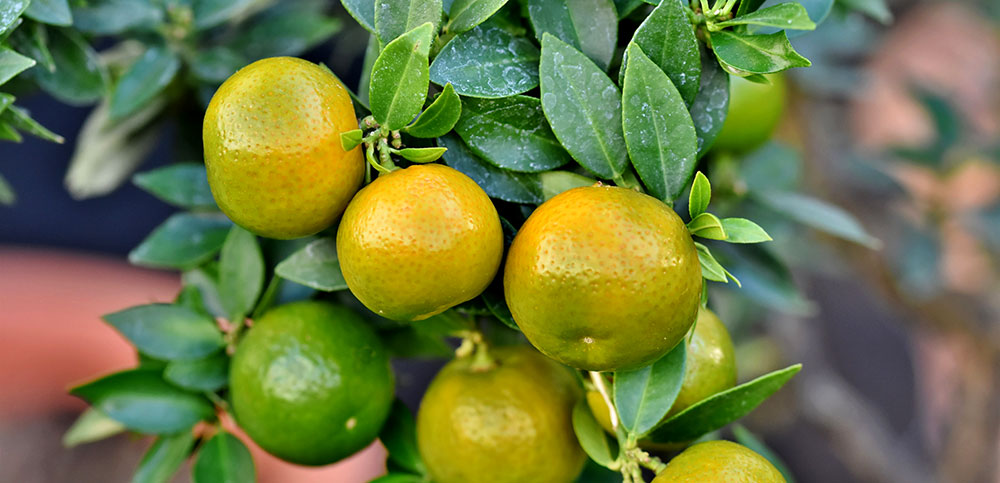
[417,346,586,483]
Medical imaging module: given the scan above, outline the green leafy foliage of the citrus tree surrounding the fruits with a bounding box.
[50,0,884,482]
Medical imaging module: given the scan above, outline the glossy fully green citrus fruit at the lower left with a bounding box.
[229,302,393,465]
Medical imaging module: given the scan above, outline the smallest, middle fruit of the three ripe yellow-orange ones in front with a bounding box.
[337,164,503,321]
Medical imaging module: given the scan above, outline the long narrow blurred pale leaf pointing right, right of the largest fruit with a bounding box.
[752,191,881,249]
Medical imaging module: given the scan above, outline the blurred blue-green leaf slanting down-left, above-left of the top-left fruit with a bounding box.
[111,46,181,120]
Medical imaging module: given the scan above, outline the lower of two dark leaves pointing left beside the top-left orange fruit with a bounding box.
[128,213,232,269]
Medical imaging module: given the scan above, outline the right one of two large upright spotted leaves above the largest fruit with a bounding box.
[622,43,698,203]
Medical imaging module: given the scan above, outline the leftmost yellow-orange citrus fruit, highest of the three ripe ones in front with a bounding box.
[202,57,364,239]
